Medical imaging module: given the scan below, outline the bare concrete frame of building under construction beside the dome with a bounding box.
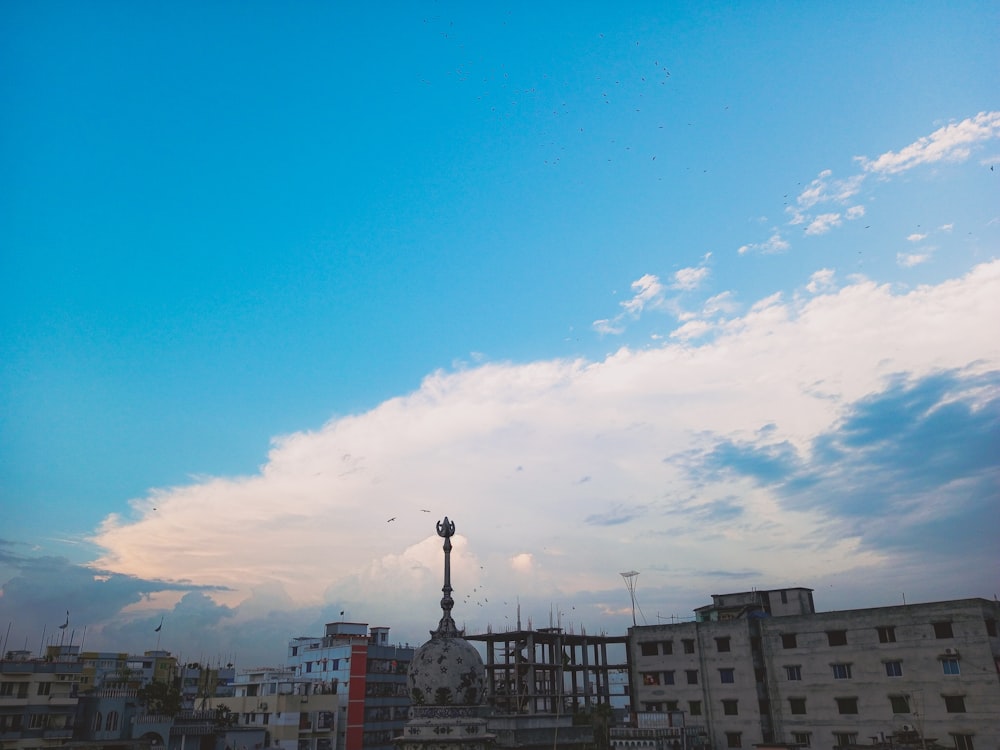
[465,627,628,716]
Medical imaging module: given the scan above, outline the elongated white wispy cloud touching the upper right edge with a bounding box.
[858,112,1000,175]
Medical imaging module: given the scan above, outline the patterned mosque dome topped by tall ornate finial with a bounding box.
[396,516,496,750]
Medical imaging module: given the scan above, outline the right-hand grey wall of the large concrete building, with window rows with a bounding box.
[761,599,1000,750]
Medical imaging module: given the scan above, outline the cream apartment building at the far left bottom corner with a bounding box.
[0,651,82,750]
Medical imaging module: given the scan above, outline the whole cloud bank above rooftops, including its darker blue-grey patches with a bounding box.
[0,261,976,654]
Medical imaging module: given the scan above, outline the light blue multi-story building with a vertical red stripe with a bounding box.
[286,622,413,750]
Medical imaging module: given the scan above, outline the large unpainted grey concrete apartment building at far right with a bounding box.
[629,588,1000,750]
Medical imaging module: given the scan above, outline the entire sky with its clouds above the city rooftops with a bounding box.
[0,2,1000,662]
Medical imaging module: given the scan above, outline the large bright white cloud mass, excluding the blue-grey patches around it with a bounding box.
[93,261,1000,638]
